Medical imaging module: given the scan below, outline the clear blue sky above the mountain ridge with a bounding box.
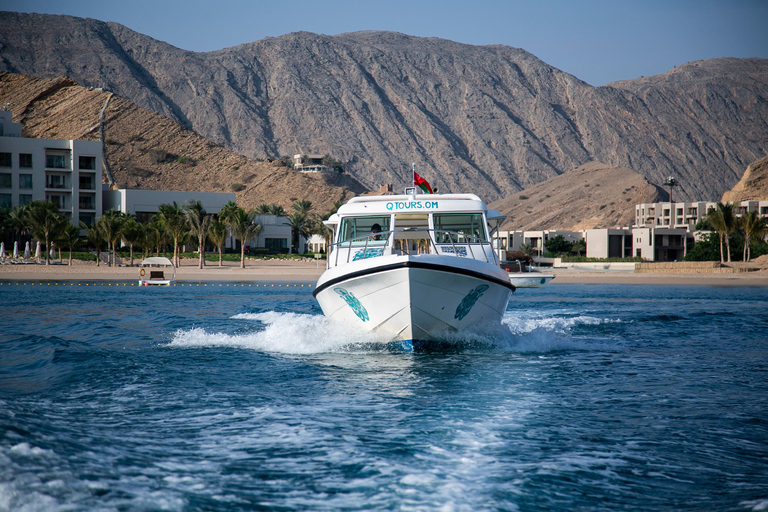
[6,0,768,85]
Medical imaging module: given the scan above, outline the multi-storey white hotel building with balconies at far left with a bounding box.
[0,110,102,226]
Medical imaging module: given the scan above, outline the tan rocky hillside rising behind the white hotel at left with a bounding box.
[0,73,364,213]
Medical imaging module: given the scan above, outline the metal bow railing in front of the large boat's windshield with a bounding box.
[328,227,499,266]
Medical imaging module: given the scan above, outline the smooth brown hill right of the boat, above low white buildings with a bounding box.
[490,162,669,231]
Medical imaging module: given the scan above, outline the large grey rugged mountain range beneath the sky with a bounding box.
[0,12,768,200]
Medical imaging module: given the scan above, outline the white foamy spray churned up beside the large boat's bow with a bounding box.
[170,311,616,354]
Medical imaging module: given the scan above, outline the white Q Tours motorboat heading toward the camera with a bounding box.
[313,189,515,342]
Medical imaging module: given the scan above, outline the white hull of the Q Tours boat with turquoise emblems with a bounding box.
[315,255,514,342]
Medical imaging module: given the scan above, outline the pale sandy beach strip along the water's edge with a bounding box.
[0,260,768,286]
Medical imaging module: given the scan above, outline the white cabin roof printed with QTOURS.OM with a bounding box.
[324,194,492,225]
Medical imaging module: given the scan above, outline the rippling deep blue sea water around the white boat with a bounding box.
[0,281,768,511]
